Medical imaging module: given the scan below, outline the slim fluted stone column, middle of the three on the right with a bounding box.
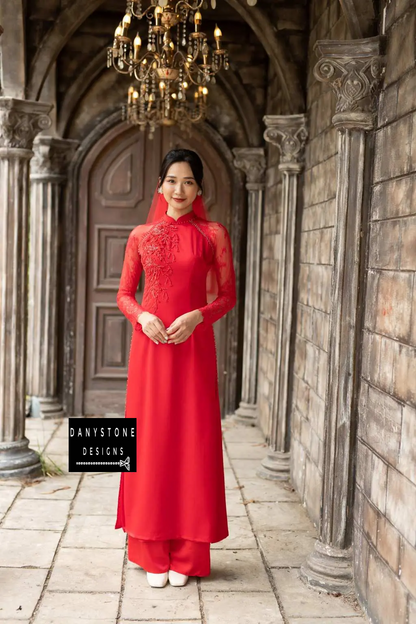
[257,115,308,480]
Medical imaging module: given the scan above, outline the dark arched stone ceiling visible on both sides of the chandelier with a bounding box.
[27,0,306,119]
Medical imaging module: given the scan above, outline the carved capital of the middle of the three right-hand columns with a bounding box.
[263,115,308,168]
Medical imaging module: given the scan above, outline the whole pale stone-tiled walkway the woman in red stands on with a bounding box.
[0,418,367,624]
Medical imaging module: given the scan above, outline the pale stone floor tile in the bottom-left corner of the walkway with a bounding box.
[0,568,48,622]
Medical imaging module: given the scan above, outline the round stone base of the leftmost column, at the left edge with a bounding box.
[0,437,43,479]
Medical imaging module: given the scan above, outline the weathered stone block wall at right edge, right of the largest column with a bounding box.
[354,1,416,624]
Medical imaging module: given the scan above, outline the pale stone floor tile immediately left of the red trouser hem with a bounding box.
[48,548,124,592]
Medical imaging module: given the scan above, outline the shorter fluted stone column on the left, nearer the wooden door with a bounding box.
[26,136,78,418]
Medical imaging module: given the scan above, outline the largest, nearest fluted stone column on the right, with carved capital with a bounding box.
[301,37,382,593]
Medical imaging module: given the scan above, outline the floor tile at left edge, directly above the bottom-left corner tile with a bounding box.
[0,528,61,568]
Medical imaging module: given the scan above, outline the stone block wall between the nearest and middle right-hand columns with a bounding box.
[291,0,350,523]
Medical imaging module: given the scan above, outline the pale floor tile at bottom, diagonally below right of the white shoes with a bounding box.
[203,592,283,624]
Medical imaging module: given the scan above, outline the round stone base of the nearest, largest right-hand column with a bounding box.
[300,541,353,594]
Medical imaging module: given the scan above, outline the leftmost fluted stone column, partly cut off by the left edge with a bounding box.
[0,98,51,478]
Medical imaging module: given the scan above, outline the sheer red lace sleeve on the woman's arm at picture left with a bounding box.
[117,228,144,329]
